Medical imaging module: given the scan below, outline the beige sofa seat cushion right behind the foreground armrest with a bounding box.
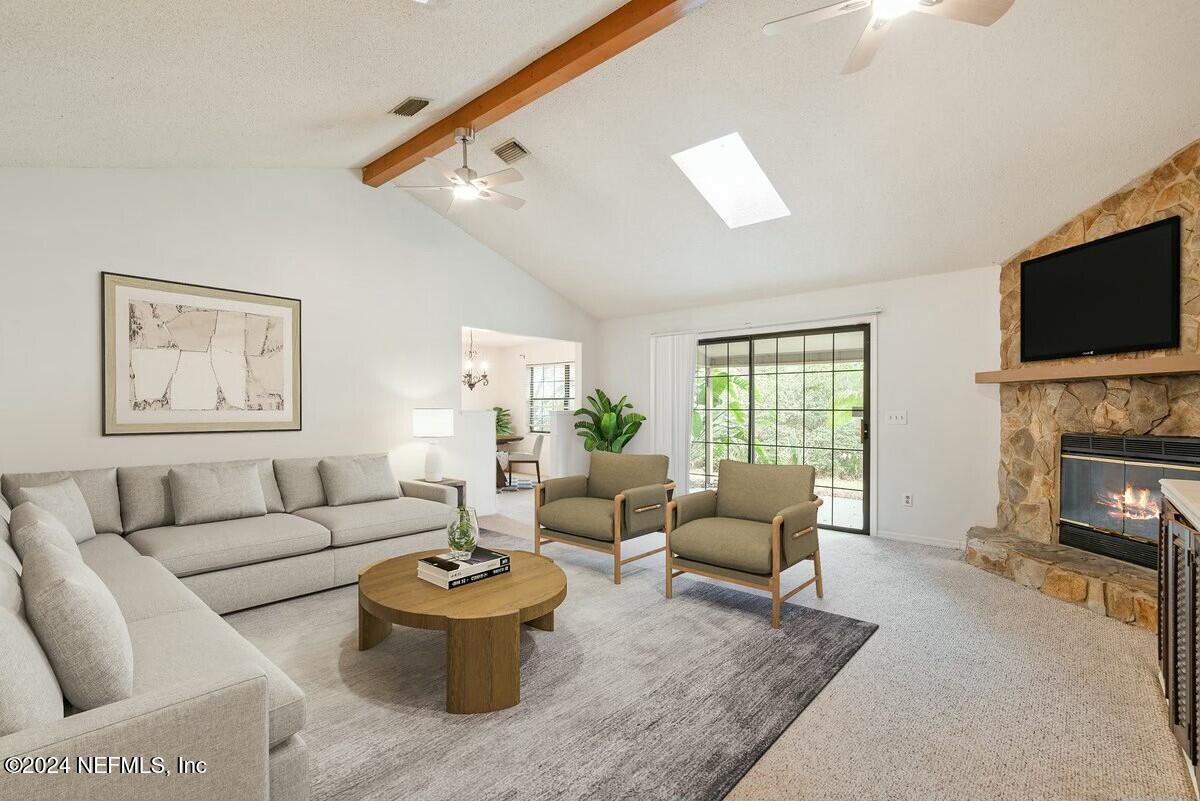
[130,609,305,746]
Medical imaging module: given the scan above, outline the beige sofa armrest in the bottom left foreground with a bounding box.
[0,664,270,801]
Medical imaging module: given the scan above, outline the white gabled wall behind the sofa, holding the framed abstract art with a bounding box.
[0,169,596,503]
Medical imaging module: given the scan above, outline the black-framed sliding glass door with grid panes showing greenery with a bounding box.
[689,325,870,534]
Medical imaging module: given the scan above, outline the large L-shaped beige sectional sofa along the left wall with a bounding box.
[0,459,455,800]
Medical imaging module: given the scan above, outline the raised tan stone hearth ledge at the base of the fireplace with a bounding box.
[966,528,1158,632]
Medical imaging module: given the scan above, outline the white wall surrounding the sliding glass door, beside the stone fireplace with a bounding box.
[600,266,1000,547]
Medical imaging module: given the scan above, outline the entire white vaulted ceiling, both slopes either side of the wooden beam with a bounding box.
[0,0,1200,317]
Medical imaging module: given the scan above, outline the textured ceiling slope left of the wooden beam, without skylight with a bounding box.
[0,0,620,167]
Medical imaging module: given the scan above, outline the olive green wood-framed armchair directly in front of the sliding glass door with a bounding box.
[666,459,824,628]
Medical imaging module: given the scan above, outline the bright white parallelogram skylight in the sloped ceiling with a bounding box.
[671,132,792,228]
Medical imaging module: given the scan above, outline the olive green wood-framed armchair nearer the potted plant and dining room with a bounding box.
[533,451,674,584]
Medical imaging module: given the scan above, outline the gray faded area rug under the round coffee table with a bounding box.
[228,532,877,801]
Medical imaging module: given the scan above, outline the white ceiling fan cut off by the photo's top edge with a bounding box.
[762,0,1015,74]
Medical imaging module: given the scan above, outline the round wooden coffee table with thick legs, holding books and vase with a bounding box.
[359,550,566,713]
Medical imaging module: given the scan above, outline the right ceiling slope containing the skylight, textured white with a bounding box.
[404,0,1200,318]
